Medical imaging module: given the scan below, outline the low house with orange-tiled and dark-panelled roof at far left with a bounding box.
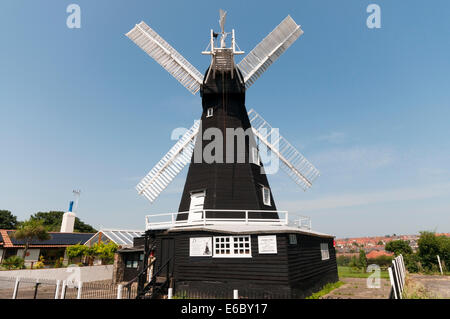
[0,229,93,265]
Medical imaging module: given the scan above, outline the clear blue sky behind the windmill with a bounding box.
[0,0,450,237]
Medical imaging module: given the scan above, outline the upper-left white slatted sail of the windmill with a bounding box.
[126,22,203,95]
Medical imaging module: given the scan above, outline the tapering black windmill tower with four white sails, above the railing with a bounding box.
[127,10,319,225]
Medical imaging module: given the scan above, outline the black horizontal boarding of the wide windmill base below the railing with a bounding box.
[151,231,338,296]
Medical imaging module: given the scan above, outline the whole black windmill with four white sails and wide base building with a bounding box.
[127,10,338,297]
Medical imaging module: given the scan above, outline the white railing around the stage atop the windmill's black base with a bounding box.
[145,209,311,230]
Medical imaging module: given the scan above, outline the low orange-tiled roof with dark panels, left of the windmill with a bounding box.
[0,230,93,247]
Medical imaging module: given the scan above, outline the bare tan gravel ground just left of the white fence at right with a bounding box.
[322,278,391,299]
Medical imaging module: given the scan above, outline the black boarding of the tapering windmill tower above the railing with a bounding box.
[177,69,278,220]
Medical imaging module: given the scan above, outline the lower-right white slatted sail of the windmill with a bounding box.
[248,109,320,190]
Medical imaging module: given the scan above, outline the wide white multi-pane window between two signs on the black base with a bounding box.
[213,235,252,257]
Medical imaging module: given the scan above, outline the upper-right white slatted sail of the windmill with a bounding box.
[238,15,303,88]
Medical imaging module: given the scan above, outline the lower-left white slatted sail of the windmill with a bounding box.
[136,121,200,202]
